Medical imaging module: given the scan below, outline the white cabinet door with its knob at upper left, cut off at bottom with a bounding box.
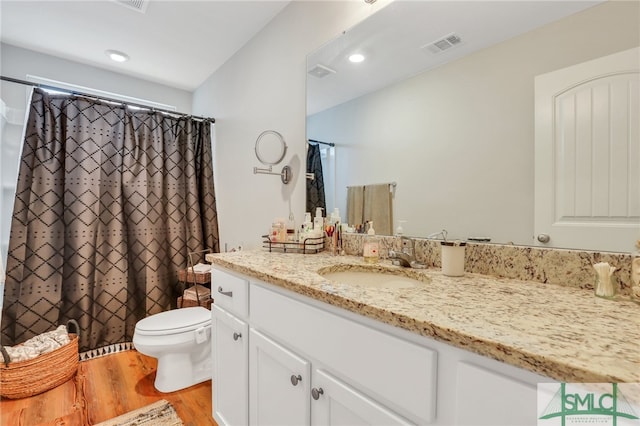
[311,370,411,426]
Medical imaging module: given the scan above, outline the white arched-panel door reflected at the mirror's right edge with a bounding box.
[534,48,640,252]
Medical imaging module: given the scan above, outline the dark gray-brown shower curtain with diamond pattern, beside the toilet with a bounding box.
[1,89,219,351]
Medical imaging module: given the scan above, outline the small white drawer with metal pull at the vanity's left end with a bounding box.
[211,267,249,318]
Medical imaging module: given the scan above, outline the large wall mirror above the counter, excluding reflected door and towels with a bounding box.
[307,1,640,251]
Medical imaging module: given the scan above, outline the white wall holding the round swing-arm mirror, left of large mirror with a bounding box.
[193,0,387,250]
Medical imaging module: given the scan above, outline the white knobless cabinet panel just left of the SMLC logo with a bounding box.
[456,362,538,426]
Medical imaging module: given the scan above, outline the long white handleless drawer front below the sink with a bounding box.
[250,283,437,424]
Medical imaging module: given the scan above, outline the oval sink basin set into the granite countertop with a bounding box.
[318,265,429,289]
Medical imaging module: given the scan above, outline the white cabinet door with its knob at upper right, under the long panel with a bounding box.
[249,329,311,426]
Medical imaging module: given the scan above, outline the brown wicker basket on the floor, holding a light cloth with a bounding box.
[0,322,79,399]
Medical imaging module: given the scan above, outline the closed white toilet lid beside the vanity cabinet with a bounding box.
[136,306,211,335]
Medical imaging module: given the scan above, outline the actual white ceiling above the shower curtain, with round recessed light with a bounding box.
[0,0,289,91]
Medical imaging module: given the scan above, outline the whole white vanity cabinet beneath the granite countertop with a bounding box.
[213,266,553,426]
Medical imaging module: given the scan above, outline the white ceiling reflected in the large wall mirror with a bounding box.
[307,0,603,115]
